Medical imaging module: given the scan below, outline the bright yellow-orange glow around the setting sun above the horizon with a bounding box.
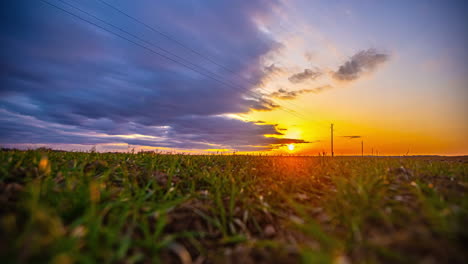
[241,74,468,155]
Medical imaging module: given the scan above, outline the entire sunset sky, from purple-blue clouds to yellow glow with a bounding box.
[0,0,468,155]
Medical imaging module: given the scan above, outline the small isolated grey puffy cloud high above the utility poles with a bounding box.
[332,49,389,81]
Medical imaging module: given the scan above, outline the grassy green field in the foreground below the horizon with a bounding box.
[0,150,468,264]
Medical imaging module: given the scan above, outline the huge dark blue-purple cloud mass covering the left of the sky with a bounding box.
[0,0,308,150]
